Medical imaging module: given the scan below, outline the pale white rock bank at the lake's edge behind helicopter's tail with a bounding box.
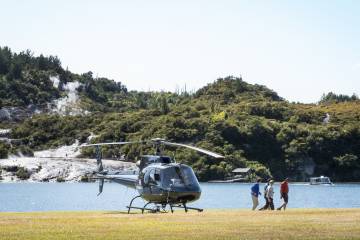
[0,141,137,182]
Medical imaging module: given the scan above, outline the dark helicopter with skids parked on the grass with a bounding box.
[82,138,224,213]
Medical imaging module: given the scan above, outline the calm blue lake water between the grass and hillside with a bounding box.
[0,183,360,212]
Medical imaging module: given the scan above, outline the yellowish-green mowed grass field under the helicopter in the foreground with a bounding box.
[0,209,360,240]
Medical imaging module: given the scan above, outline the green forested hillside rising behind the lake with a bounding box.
[0,47,360,181]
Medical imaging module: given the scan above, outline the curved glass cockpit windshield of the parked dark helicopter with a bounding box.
[161,165,199,188]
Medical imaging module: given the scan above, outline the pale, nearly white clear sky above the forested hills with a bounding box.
[0,0,360,103]
